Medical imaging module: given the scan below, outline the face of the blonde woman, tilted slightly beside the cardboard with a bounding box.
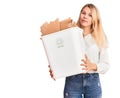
[80,7,92,28]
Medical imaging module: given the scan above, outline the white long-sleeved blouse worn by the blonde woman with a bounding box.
[84,34,110,74]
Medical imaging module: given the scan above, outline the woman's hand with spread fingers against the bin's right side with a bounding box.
[81,55,97,72]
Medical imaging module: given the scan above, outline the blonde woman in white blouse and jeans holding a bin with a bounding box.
[50,4,109,98]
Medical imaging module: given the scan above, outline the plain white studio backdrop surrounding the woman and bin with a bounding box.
[0,0,120,98]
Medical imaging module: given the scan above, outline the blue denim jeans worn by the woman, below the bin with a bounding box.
[64,73,102,98]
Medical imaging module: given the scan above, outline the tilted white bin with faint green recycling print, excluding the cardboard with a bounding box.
[41,27,85,79]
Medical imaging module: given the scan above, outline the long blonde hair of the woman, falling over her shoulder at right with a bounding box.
[77,4,107,47]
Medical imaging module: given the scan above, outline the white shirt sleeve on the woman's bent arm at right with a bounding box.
[97,48,110,74]
